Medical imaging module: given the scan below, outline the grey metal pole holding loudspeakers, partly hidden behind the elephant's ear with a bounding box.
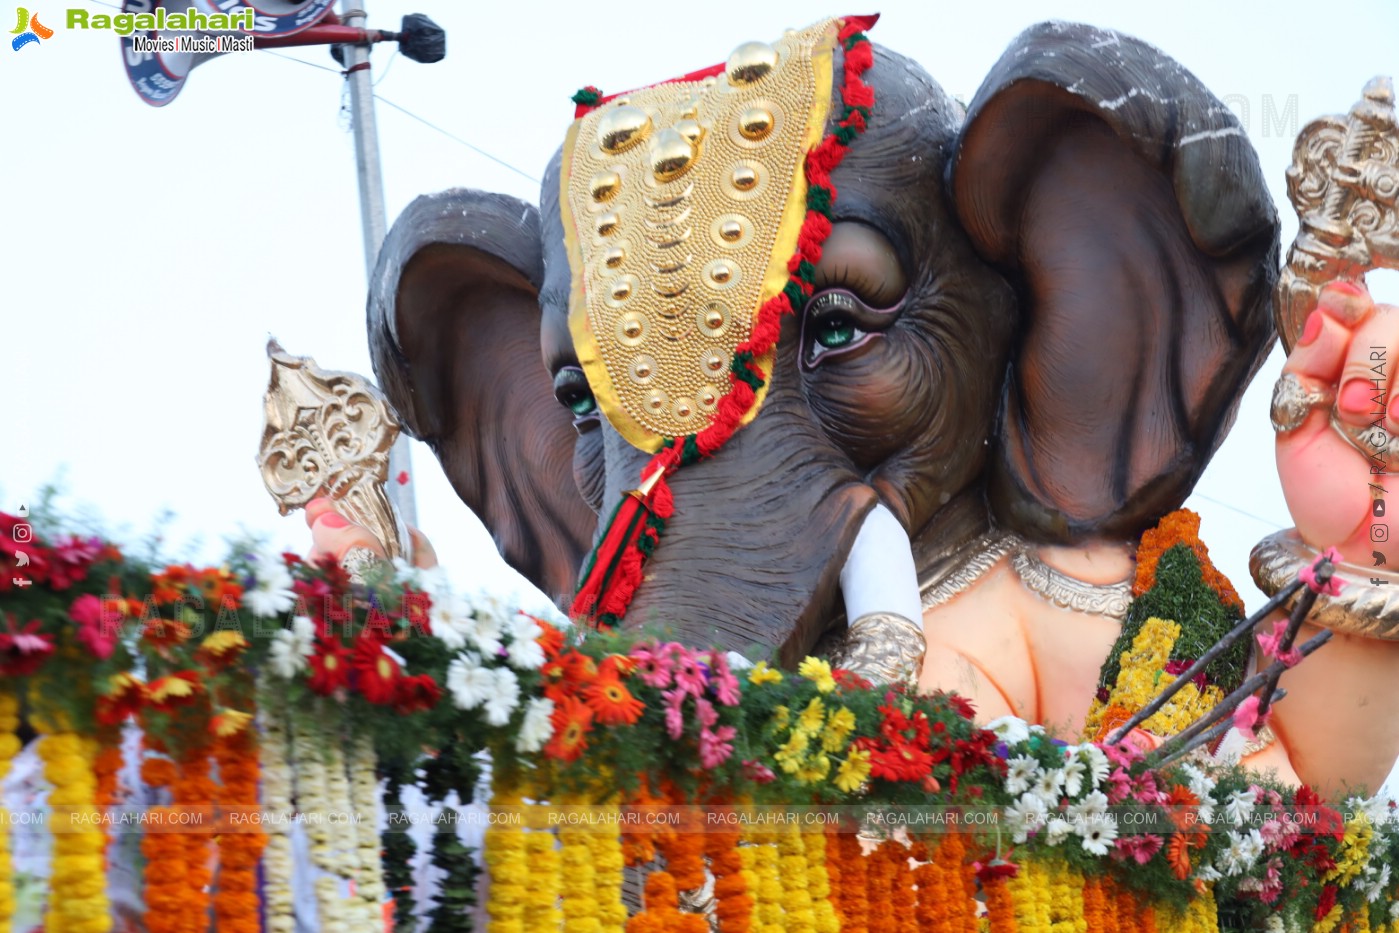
[340,3,418,531]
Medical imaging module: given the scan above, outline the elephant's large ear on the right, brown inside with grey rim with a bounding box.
[949,22,1279,541]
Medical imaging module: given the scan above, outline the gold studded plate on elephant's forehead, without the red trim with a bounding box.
[561,20,838,452]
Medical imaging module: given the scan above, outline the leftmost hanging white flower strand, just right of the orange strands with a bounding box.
[257,699,297,933]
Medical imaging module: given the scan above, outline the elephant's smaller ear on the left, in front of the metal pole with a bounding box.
[368,189,596,607]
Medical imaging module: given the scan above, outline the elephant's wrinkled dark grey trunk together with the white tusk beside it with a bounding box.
[607,360,919,664]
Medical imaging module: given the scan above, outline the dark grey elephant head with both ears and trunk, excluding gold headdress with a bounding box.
[368,24,1279,662]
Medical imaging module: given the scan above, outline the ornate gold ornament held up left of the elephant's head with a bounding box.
[257,340,407,558]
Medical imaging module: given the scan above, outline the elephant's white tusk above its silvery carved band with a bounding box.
[841,505,923,628]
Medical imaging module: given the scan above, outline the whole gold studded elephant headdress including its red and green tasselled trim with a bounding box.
[560,17,876,624]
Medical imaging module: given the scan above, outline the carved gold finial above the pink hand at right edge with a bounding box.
[1274,77,1399,352]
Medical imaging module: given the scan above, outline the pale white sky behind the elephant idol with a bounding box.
[0,0,1399,621]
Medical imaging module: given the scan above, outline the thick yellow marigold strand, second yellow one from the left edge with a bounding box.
[39,732,112,933]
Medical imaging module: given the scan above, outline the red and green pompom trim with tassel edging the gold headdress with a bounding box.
[569,15,879,628]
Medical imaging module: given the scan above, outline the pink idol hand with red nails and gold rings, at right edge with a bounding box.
[1273,281,1399,567]
